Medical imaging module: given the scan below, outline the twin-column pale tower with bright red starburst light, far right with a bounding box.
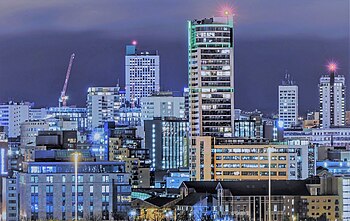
[319,63,345,128]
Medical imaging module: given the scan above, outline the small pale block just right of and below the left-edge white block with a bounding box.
[21,120,49,147]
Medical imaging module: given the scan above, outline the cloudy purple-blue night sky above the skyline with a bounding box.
[0,0,350,113]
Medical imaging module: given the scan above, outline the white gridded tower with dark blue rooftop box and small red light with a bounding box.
[125,43,160,106]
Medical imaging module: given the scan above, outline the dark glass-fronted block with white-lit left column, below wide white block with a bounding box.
[145,118,189,170]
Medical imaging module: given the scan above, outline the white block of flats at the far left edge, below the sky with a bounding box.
[0,102,29,138]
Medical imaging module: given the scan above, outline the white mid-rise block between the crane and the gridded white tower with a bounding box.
[86,87,120,130]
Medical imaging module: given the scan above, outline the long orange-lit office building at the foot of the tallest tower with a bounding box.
[190,137,315,181]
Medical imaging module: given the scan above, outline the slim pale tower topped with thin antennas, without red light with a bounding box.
[278,73,299,128]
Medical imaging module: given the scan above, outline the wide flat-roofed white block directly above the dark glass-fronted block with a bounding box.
[141,92,185,120]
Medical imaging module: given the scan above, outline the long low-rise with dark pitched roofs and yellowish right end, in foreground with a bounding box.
[176,173,343,221]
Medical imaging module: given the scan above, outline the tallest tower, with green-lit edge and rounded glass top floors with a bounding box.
[188,16,234,137]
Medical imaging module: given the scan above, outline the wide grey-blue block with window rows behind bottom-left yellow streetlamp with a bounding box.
[18,161,131,220]
